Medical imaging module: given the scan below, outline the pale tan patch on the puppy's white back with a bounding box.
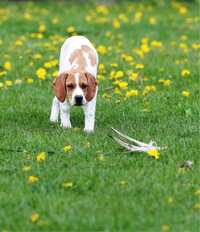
[69,45,97,71]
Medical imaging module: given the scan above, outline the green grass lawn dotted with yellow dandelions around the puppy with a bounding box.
[0,1,200,232]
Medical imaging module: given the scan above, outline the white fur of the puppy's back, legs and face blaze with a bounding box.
[50,36,98,132]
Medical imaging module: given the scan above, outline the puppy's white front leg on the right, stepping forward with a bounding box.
[83,96,96,133]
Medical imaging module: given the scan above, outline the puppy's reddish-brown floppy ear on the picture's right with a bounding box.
[85,72,97,101]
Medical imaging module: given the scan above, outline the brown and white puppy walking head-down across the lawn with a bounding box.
[50,36,98,133]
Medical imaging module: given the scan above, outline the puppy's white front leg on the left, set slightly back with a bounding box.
[60,101,72,128]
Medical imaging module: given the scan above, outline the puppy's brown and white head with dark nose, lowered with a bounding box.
[53,72,97,106]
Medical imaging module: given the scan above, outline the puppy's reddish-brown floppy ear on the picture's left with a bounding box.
[53,72,68,102]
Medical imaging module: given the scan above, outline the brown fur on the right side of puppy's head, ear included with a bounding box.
[80,72,97,102]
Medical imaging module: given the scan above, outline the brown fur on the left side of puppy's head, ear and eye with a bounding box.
[53,72,76,102]
